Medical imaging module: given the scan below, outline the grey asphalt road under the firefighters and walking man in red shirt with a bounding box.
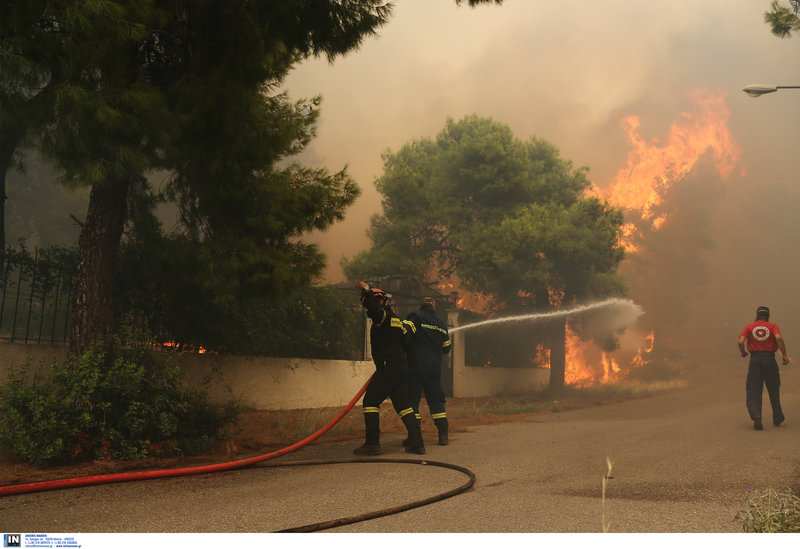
[0,364,800,533]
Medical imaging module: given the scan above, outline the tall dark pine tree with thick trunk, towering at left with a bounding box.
[0,0,390,351]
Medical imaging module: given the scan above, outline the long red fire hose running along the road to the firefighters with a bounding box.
[0,376,372,497]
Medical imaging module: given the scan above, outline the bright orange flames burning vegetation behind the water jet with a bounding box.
[442,90,741,387]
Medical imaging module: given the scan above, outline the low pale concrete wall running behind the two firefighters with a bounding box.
[0,332,550,410]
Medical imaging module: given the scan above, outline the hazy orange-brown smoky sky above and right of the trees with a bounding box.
[285,0,800,353]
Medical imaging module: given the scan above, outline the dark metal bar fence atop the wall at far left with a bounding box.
[0,250,74,343]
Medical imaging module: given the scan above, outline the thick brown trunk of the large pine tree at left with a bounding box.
[69,180,130,354]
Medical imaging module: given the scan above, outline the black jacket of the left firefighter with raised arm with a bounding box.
[361,290,414,368]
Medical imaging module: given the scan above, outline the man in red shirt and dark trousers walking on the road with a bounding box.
[738,307,789,431]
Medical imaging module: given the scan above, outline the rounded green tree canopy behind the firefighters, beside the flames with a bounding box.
[344,115,623,311]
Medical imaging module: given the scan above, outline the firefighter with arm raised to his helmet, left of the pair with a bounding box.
[353,281,425,456]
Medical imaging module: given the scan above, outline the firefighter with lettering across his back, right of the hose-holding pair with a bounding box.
[406,297,450,446]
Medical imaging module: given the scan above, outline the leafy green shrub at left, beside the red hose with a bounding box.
[0,346,238,466]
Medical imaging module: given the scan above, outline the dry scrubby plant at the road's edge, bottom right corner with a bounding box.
[736,489,800,533]
